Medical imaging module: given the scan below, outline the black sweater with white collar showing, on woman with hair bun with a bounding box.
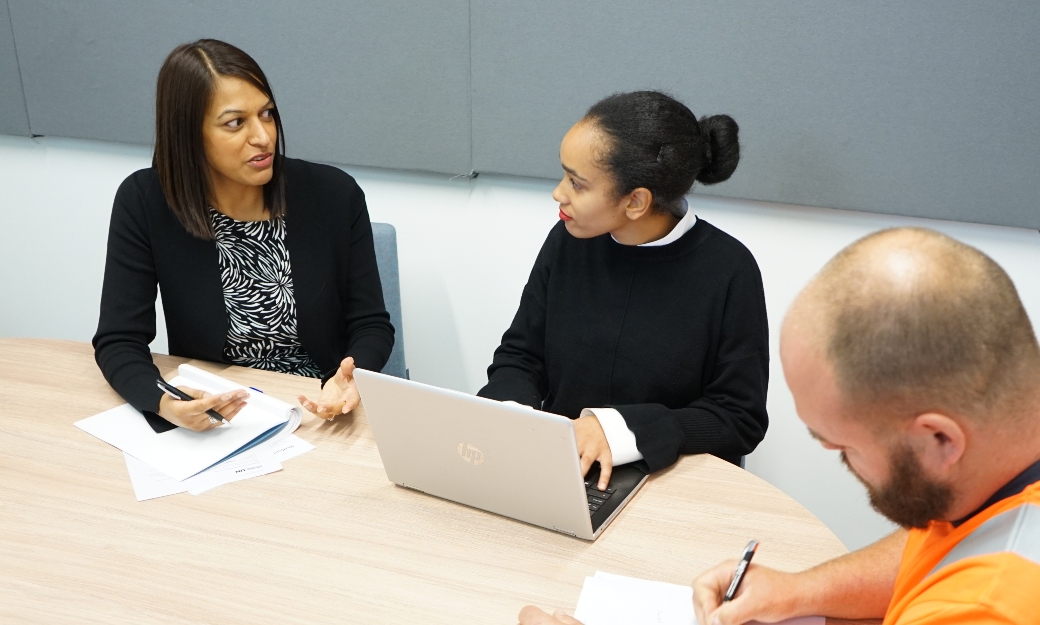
[477,220,769,471]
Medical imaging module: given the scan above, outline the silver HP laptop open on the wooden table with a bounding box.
[354,369,647,541]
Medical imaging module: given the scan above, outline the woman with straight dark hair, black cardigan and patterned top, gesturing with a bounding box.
[94,40,394,431]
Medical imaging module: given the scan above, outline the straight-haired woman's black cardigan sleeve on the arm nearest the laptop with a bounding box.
[322,180,394,384]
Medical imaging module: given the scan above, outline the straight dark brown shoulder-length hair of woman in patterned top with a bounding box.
[152,40,285,239]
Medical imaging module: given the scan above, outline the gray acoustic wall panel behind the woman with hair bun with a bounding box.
[471,0,1040,228]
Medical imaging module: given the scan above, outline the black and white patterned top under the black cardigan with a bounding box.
[209,208,321,377]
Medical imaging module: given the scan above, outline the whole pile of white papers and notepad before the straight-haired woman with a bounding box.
[76,365,314,501]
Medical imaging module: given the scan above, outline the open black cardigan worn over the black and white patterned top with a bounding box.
[93,158,394,412]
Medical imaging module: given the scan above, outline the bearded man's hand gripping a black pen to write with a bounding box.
[694,559,800,625]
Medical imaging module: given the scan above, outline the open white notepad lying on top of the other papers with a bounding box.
[76,365,302,480]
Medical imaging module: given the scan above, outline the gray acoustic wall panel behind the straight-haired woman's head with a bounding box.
[9,0,470,173]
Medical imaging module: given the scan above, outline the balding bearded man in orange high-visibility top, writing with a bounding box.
[520,229,1040,625]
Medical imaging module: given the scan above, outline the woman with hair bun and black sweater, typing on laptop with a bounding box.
[478,92,769,489]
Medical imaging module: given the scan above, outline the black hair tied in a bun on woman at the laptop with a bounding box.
[584,92,740,216]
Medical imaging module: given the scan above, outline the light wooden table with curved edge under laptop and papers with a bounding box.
[0,339,861,625]
